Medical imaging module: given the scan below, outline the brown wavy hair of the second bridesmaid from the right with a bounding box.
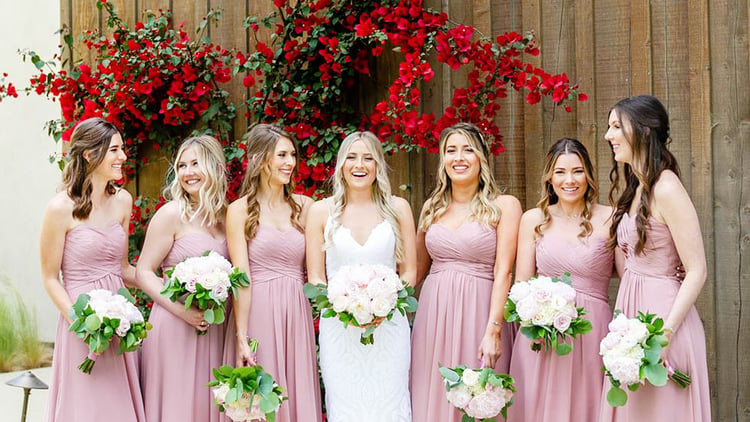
[534,138,599,239]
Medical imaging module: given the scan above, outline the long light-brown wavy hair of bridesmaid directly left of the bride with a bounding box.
[240,123,303,240]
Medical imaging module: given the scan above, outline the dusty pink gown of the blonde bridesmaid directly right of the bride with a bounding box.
[411,221,512,422]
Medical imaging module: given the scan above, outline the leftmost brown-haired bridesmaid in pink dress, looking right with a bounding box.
[39,118,145,422]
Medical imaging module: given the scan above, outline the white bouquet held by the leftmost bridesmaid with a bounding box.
[70,288,151,374]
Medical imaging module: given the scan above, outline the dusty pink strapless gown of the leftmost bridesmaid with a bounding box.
[47,221,146,422]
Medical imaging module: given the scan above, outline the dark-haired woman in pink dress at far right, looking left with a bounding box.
[600,95,711,421]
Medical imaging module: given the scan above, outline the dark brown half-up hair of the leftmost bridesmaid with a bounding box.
[62,117,120,220]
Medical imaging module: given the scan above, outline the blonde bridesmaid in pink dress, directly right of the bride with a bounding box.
[411,123,521,422]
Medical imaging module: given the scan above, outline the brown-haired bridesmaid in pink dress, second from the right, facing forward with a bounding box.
[508,138,614,422]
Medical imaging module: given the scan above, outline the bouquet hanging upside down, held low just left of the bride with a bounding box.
[208,339,287,422]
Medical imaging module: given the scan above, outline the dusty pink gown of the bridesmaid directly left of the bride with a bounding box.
[222,224,322,422]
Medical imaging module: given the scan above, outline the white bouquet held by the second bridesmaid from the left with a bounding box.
[161,251,250,335]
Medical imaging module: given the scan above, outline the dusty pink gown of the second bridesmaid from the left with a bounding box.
[141,233,228,422]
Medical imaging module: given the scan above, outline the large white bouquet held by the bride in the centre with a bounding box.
[304,264,424,344]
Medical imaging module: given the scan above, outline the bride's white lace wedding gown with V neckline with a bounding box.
[319,218,411,422]
